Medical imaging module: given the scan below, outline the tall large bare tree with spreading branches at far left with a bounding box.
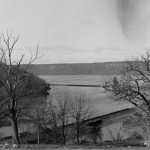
[0,33,49,144]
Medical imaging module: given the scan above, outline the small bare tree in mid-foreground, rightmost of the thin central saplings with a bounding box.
[70,93,94,145]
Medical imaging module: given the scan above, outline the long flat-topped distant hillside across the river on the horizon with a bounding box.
[23,62,124,75]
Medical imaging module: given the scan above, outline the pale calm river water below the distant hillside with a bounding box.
[40,75,132,115]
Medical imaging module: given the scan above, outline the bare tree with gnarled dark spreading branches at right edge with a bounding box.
[102,51,150,140]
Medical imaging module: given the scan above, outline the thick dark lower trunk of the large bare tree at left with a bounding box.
[10,117,20,145]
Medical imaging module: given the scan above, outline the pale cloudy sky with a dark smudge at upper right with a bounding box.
[0,0,150,63]
